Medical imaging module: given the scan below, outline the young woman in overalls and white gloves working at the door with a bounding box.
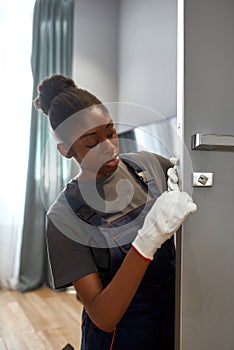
[35,75,196,350]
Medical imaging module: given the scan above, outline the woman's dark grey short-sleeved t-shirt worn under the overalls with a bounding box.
[46,151,172,289]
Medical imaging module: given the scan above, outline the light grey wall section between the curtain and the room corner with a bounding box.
[73,0,119,102]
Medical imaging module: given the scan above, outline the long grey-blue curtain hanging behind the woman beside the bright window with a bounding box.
[18,0,74,292]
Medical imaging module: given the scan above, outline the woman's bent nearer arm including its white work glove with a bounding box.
[73,191,197,332]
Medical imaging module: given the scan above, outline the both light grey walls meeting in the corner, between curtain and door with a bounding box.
[73,0,177,125]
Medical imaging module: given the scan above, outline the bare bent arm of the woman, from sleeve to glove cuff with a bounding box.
[73,248,150,332]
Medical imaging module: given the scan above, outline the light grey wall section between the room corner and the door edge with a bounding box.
[119,0,177,123]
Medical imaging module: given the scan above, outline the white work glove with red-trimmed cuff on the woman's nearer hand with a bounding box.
[132,191,197,260]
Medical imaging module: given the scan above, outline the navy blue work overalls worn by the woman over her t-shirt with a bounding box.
[65,157,175,350]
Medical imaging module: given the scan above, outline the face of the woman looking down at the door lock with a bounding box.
[67,108,119,177]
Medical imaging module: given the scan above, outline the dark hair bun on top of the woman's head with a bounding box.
[34,74,78,115]
